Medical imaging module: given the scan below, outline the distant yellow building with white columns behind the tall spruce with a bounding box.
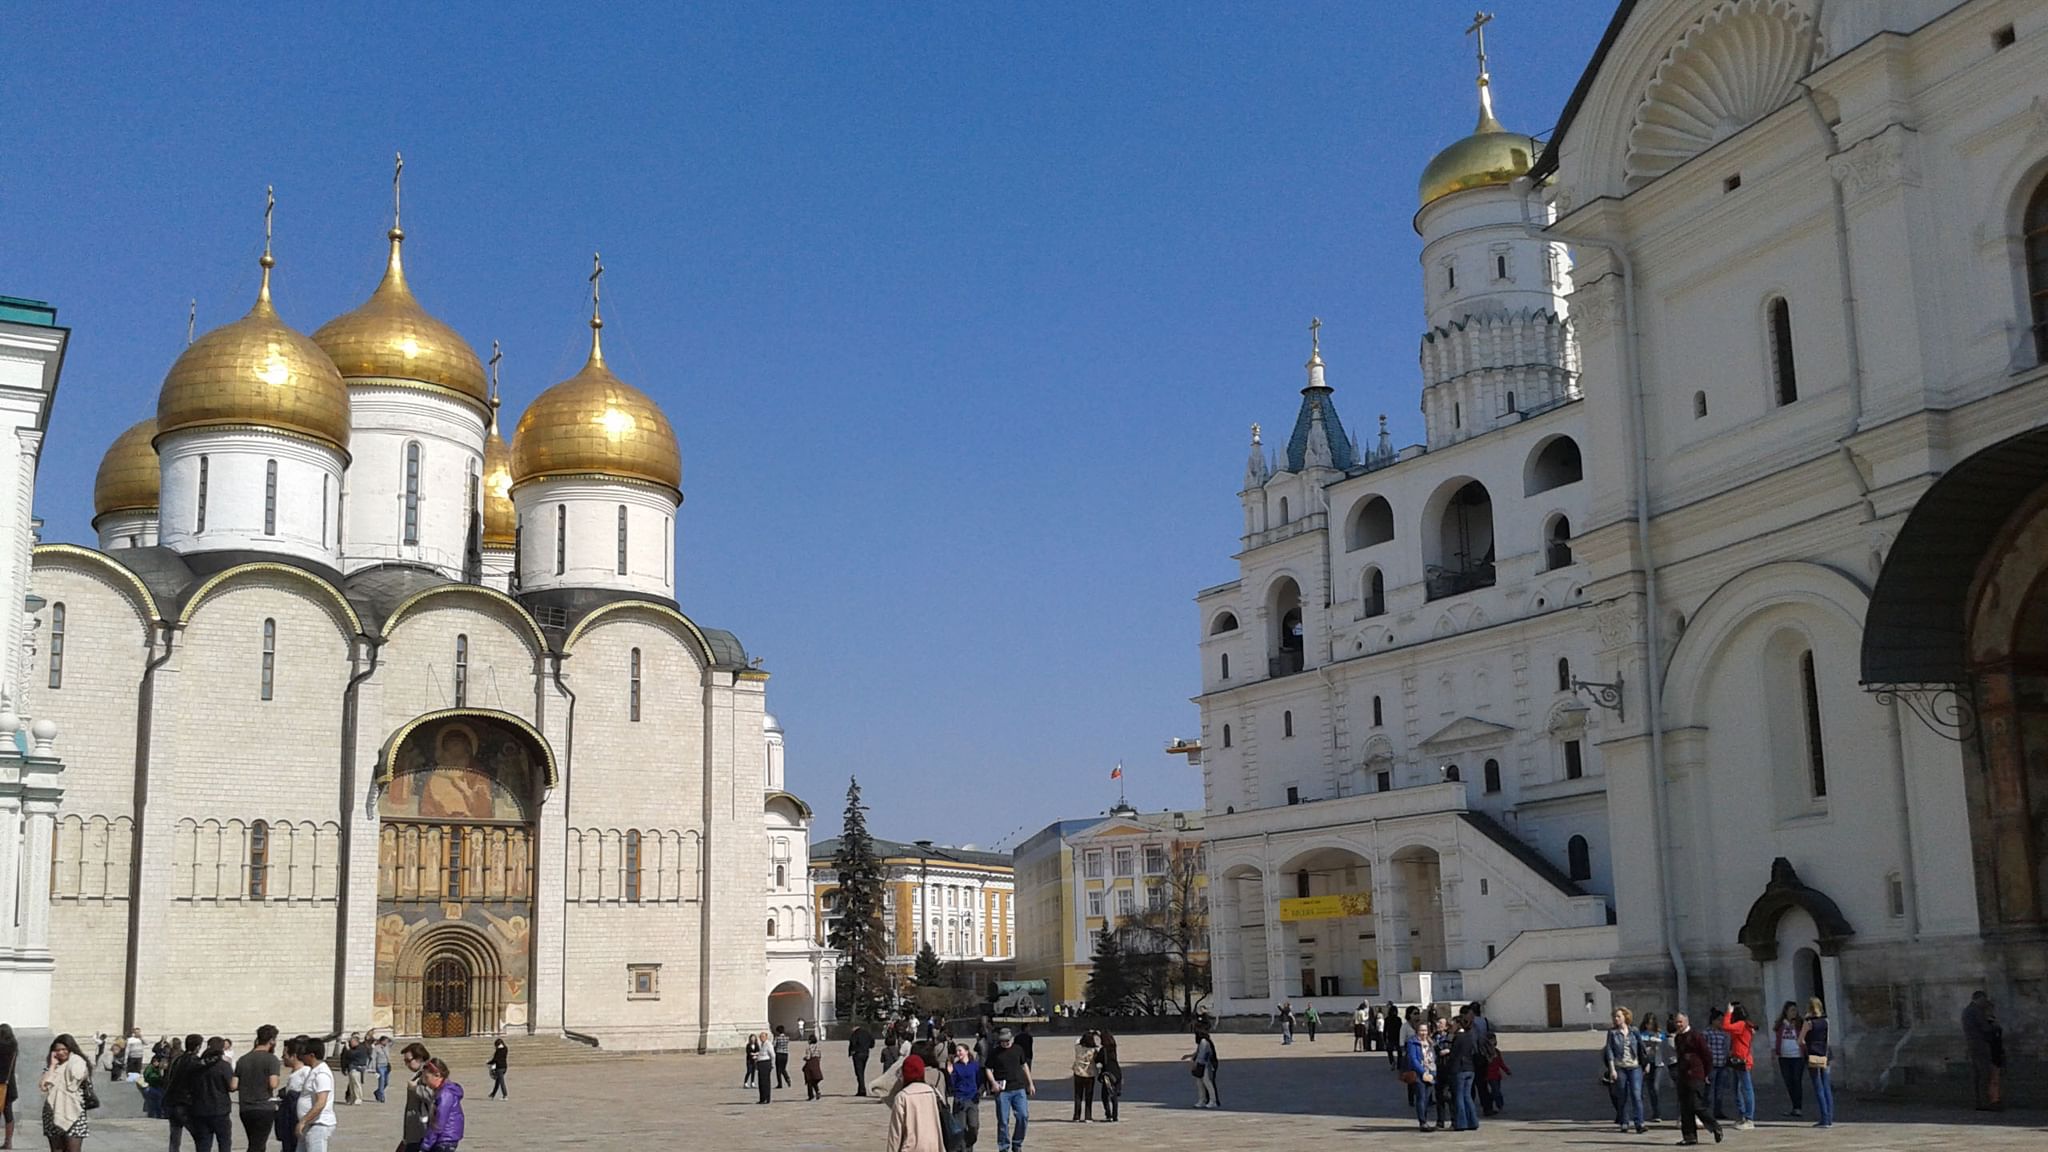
[811,838,1018,986]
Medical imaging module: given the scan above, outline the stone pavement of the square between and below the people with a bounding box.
[72,1033,2048,1152]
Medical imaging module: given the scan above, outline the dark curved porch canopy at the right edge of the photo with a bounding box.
[1862,428,2048,691]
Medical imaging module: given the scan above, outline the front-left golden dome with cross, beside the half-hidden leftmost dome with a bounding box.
[156,246,348,453]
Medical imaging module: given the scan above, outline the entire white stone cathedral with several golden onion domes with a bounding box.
[33,199,770,1047]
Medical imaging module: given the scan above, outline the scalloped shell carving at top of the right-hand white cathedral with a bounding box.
[1624,0,1821,189]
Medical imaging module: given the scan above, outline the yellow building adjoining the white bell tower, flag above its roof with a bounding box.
[1016,806,1208,1004]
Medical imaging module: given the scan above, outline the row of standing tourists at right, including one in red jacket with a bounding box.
[1602,998,1835,1144]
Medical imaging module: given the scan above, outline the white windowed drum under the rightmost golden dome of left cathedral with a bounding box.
[512,478,676,596]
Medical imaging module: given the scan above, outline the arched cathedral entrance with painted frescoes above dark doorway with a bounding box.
[373,709,553,1037]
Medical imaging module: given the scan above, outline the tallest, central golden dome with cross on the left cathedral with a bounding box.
[313,228,492,414]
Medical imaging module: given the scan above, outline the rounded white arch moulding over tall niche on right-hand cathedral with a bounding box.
[1663,560,1870,728]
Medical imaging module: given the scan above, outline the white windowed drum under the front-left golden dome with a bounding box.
[158,428,342,568]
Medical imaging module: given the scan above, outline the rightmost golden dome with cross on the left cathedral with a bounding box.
[512,316,682,498]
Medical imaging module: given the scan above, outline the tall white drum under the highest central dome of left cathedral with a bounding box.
[342,379,485,576]
